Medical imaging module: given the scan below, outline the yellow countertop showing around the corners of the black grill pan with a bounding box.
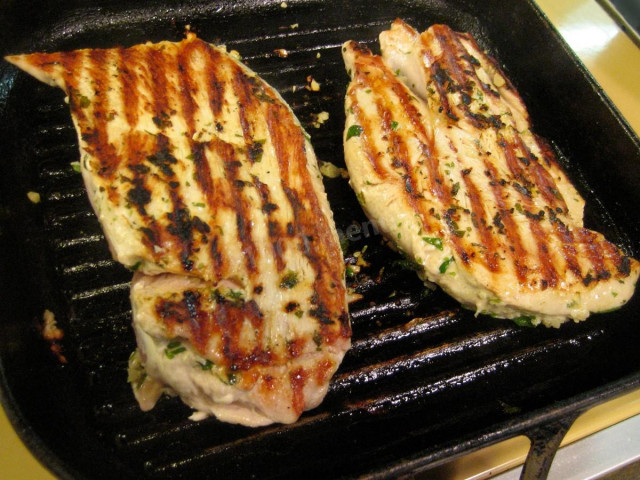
[0,0,640,480]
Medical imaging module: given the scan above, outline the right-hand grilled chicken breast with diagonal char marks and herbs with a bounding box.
[343,21,640,326]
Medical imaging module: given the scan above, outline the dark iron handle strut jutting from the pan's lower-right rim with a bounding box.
[520,411,582,480]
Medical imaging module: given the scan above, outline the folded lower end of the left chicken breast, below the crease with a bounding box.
[131,272,349,426]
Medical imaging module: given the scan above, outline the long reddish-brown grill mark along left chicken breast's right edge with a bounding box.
[266,104,351,343]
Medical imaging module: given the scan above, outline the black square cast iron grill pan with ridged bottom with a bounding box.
[0,0,640,479]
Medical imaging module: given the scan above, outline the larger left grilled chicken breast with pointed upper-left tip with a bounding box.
[7,34,351,425]
